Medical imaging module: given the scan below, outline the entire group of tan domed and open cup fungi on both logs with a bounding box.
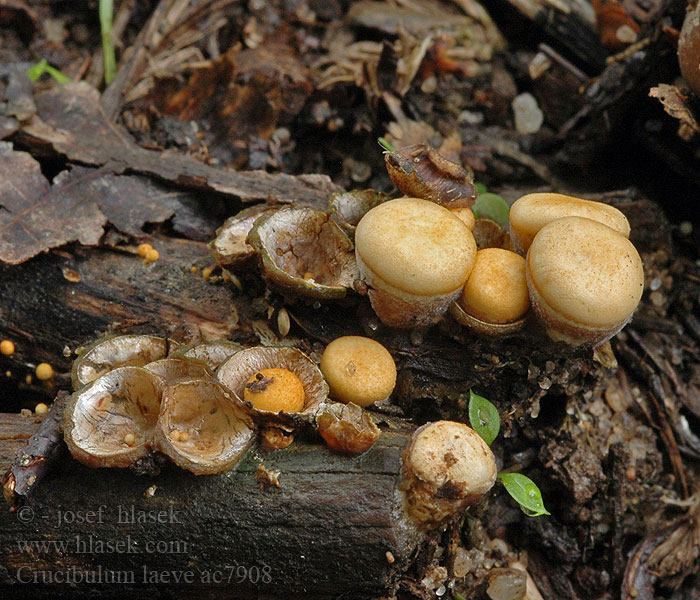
[64,146,643,524]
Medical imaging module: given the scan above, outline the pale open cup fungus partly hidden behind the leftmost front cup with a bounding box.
[71,335,179,390]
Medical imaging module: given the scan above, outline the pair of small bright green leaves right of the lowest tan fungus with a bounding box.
[469,390,550,517]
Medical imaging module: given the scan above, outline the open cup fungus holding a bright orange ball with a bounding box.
[216,346,328,429]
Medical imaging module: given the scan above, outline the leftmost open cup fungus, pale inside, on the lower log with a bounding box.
[63,367,164,467]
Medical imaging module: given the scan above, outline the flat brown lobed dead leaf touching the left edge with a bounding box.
[0,142,220,264]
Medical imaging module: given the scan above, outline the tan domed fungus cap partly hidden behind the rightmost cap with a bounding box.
[510,192,630,253]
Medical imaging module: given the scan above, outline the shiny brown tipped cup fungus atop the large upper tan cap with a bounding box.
[384,144,476,208]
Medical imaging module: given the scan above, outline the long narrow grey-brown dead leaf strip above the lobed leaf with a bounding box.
[17,83,340,207]
